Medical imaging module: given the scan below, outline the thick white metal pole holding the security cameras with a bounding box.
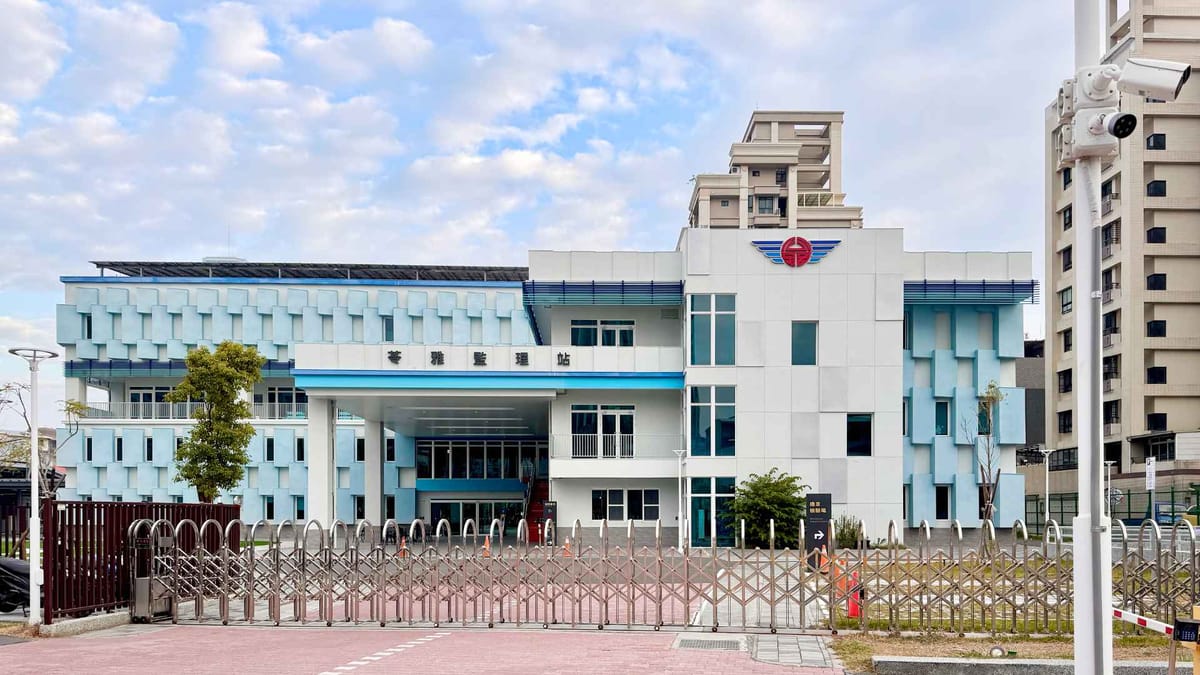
[1073,0,1112,675]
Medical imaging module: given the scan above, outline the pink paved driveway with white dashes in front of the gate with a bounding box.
[0,626,842,675]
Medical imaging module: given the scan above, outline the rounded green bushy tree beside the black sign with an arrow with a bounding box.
[725,468,809,549]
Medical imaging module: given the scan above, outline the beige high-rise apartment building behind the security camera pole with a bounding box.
[1045,0,1200,492]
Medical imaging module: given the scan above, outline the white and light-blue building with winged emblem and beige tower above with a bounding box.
[58,112,1037,545]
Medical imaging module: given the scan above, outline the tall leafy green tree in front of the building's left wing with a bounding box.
[166,341,266,502]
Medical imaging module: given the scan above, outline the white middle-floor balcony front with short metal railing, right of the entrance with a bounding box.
[550,432,684,479]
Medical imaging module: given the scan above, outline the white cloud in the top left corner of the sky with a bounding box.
[0,0,70,101]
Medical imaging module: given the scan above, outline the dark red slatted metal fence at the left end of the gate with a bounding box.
[42,500,241,623]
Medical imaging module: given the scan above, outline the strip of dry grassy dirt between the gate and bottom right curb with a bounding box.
[833,635,1192,673]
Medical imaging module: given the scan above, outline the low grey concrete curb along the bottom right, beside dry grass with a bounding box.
[871,656,1166,675]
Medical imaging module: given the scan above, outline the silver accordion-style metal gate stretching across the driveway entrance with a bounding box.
[138,511,1198,634]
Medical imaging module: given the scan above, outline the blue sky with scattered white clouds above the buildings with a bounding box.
[0,0,1072,428]
